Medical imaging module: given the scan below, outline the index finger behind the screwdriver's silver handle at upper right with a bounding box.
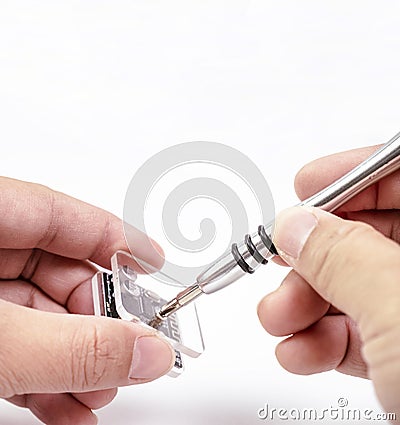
[295,145,400,212]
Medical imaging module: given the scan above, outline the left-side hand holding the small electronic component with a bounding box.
[0,178,174,425]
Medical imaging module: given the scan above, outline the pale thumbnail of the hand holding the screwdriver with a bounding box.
[273,207,318,259]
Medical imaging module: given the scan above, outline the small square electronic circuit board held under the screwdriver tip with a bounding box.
[92,251,204,376]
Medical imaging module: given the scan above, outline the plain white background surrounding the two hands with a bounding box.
[0,0,400,425]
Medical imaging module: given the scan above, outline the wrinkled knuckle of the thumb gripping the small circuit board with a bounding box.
[72,323,116,389]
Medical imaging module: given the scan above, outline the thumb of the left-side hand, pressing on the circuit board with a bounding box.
[0,301,174,398]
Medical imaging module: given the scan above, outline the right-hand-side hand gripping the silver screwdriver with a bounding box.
[258,147,400,418]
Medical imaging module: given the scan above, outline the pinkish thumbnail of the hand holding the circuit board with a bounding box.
[129,335,174,379]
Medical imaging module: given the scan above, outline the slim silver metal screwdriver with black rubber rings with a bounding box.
[155,133,400,317]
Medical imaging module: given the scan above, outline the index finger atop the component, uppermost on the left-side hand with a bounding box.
[0,177,164,268]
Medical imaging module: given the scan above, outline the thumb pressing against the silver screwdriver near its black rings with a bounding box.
[274,207,400,340]
